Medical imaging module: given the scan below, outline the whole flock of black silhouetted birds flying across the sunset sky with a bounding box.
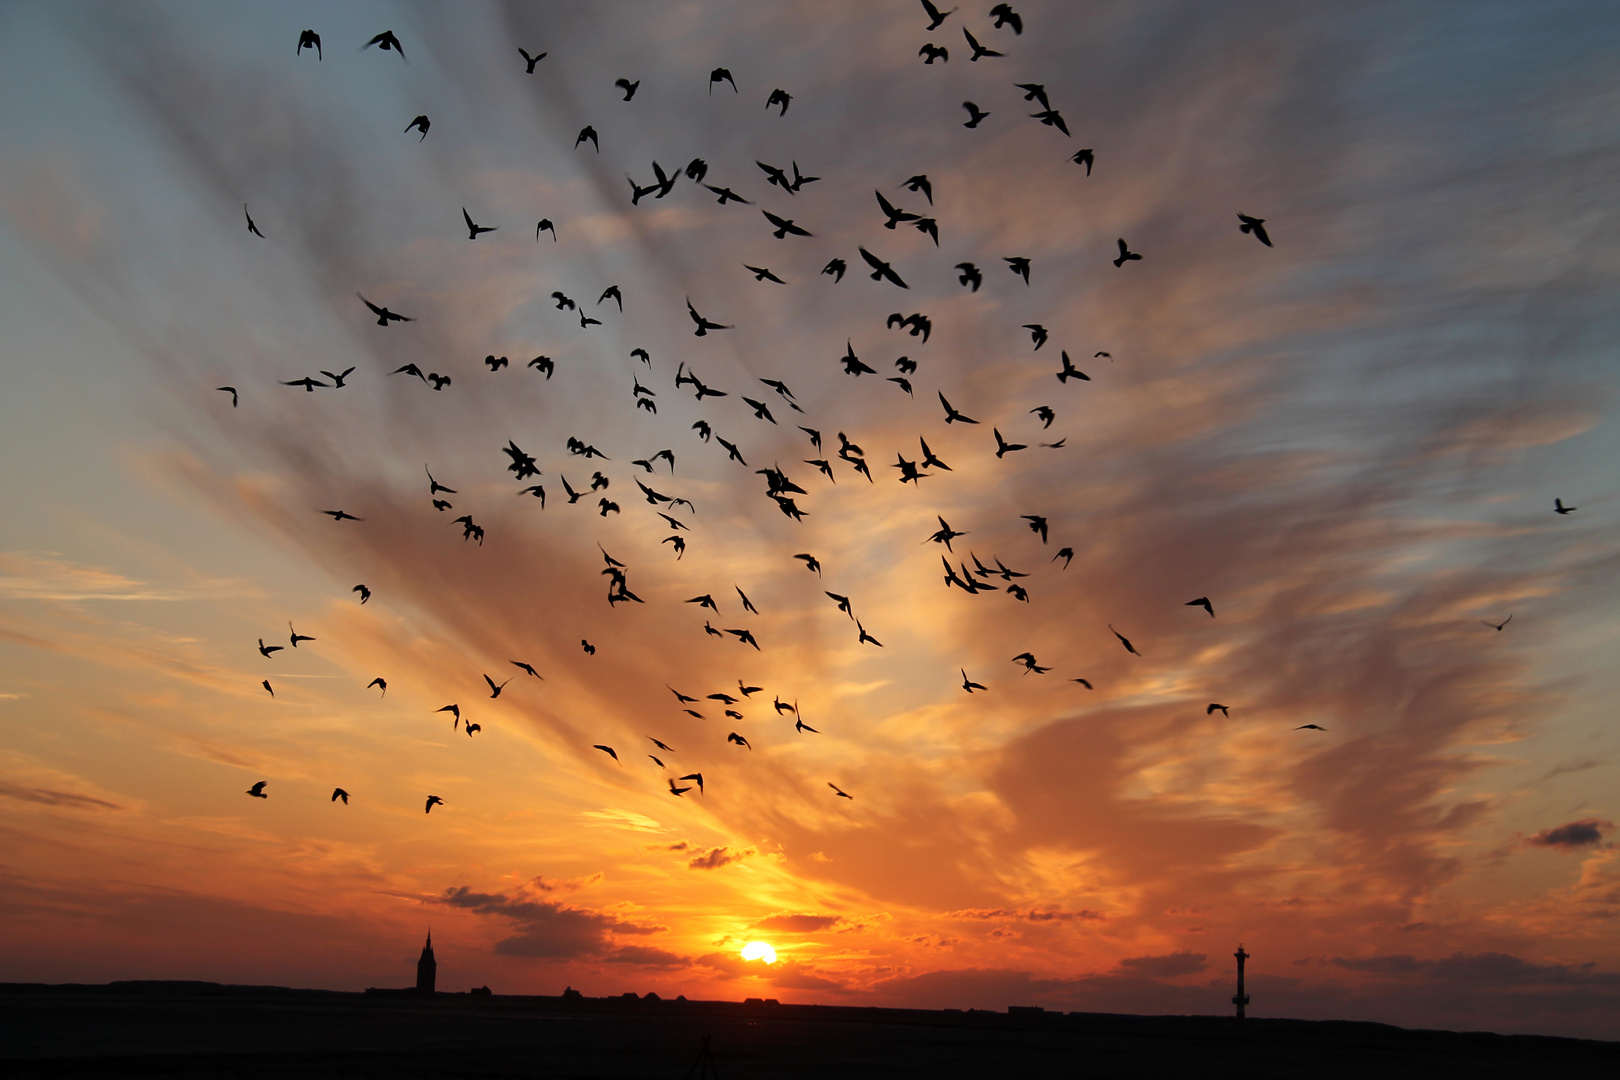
[231,0,1576,813]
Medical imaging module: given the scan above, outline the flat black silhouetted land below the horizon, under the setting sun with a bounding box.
[0,983,1620,1080]
